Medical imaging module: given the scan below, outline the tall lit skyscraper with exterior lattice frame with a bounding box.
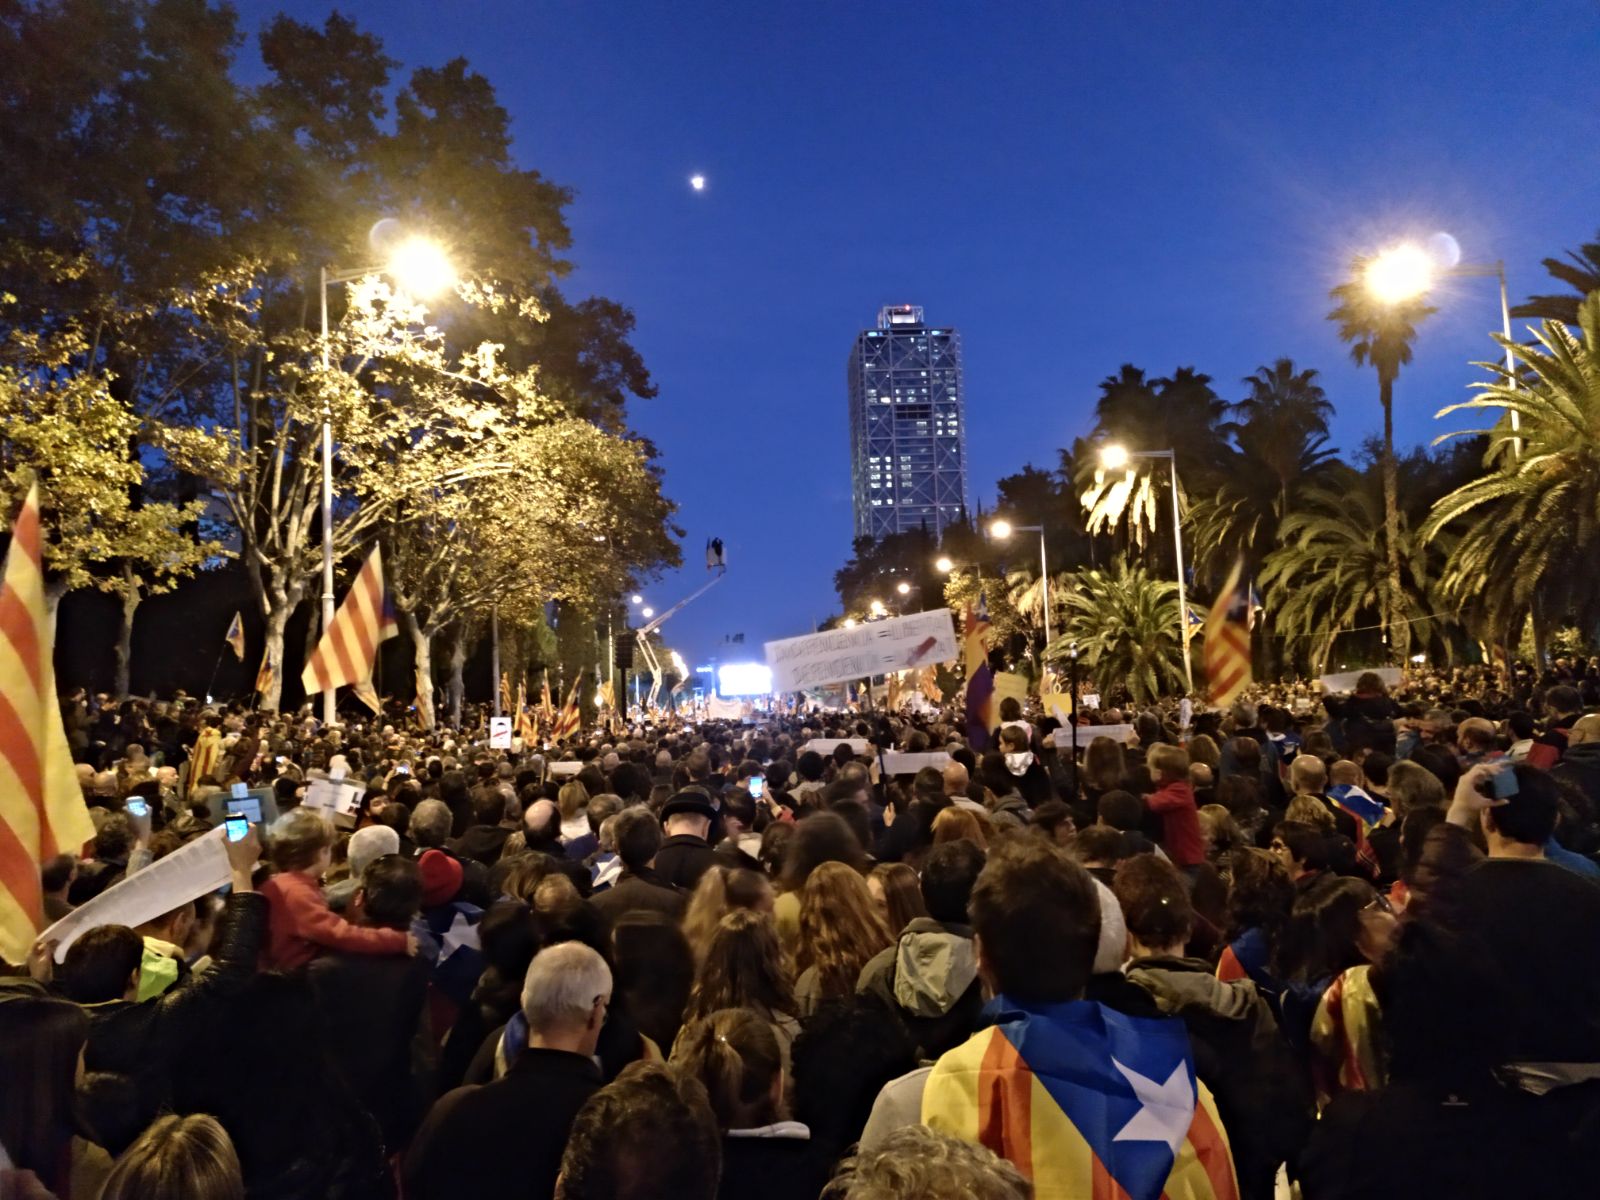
[848,304,966,538]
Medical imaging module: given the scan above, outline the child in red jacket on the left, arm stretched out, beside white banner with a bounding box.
[261,808,416,971]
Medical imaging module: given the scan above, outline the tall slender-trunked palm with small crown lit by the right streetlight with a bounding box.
[1328,256,1437,654]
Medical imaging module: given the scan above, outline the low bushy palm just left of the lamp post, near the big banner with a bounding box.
[1050,562,1184,702]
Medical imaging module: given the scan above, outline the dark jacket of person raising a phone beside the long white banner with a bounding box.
[83,891,267,1123]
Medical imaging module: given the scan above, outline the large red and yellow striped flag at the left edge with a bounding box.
[0,483,94,963]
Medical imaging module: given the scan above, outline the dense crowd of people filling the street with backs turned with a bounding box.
[9,662,1600,1200]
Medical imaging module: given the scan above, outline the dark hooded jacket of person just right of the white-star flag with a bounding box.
[1126,958,1312,1200]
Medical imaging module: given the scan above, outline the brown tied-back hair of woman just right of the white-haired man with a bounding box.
[672,1008,784,1131]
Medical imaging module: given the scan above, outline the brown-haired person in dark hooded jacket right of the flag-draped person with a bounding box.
[1114,854,1312,1200]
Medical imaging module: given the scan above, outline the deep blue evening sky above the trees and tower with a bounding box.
[240,0,1600,662]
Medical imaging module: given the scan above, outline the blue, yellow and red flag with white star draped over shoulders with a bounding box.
[922,995,1238,1200]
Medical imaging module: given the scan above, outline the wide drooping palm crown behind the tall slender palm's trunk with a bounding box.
[1261,462,1446,674]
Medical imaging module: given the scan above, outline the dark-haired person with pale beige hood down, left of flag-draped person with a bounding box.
[856,838,984,1058]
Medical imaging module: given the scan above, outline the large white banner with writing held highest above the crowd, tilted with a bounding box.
[766,608,957,691]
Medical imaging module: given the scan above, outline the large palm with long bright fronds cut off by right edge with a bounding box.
[1422,293,1600,662]
